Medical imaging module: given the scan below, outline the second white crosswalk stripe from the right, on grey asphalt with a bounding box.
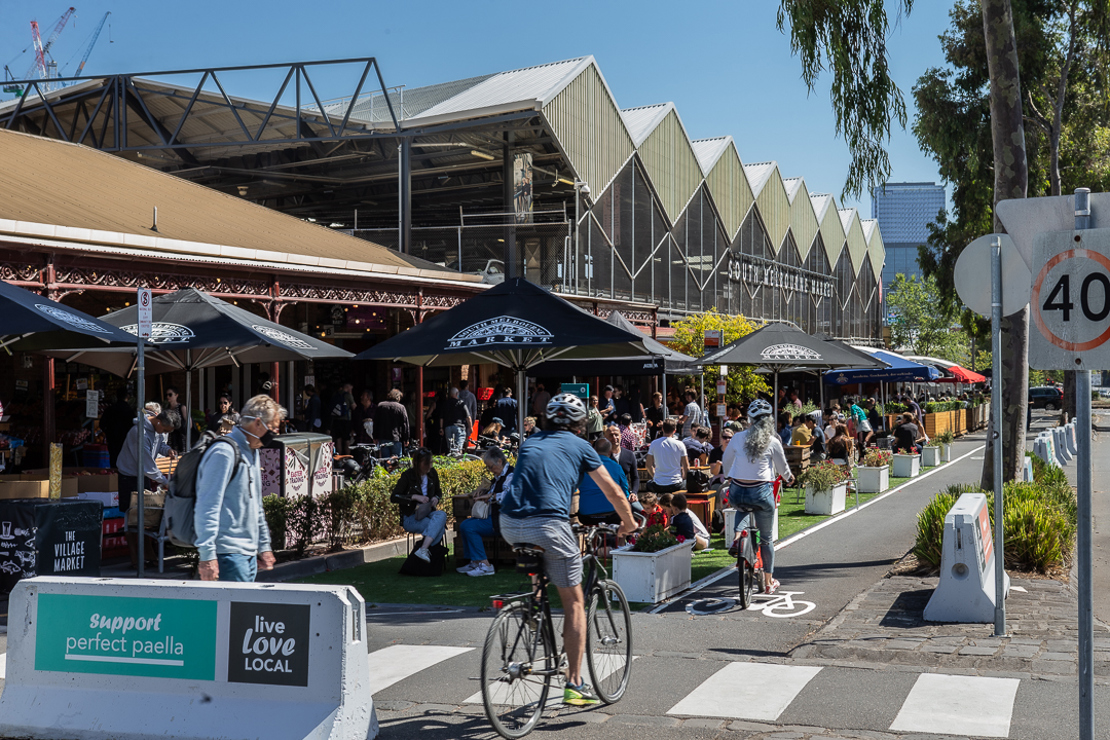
[667,662,821,722]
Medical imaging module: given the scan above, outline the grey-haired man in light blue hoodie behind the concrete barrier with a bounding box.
[193,395,277,582]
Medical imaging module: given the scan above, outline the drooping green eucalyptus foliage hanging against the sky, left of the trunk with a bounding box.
[778,0,914,197]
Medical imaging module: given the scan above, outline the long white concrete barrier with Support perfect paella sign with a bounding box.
[0,578,377,740]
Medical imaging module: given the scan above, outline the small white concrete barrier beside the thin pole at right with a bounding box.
[925,494,1010,624]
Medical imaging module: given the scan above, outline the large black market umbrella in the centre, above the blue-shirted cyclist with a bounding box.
[355,277,650,429]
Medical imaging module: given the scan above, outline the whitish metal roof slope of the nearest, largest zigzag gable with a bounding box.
[412,57,594,121]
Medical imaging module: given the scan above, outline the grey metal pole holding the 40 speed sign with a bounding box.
[1076,187,1094,740]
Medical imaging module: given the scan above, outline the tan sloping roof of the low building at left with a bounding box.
[0,130,455,276]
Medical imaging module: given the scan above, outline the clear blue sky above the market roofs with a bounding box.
[0,0,950,217]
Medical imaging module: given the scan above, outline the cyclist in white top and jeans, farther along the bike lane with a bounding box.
[722,398,794,594]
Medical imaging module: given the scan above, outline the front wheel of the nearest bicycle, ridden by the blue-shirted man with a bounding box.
[586,580,632,704]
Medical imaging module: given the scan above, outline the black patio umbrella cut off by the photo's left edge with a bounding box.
[0,281,139,352]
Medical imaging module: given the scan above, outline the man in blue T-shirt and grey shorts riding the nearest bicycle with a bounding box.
[501,393,636,707]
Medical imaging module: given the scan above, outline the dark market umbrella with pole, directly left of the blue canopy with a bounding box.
[700,324,886,417]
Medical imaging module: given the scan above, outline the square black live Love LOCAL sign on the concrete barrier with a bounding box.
[228,601,311,686]
